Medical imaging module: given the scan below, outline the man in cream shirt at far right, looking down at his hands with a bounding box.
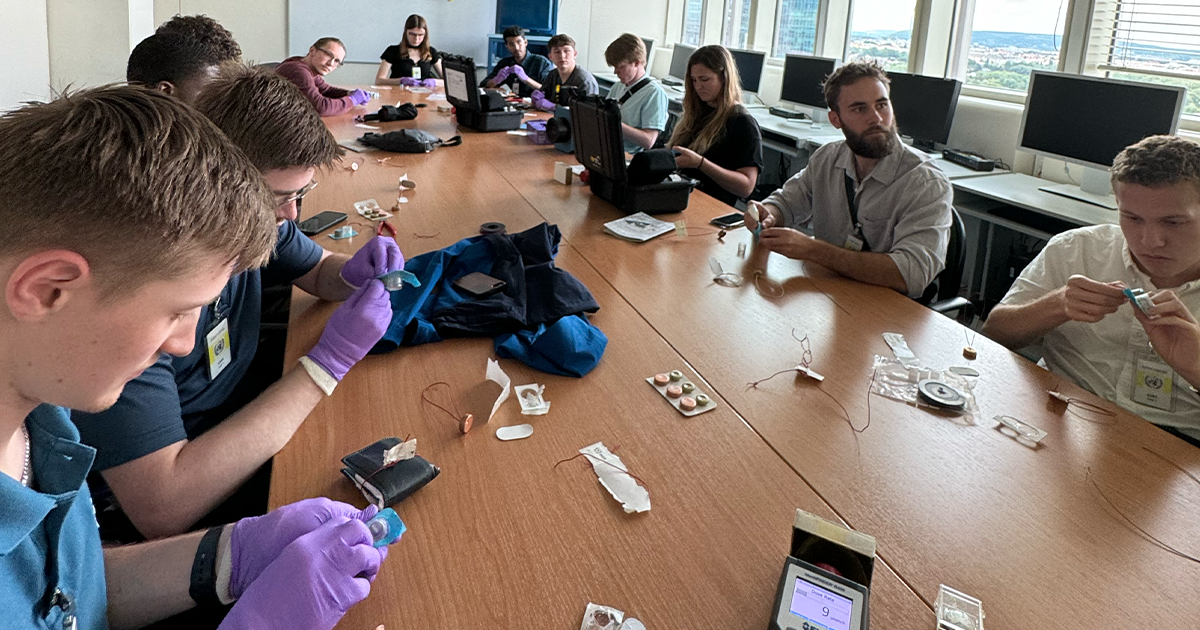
[983,136,1200,445]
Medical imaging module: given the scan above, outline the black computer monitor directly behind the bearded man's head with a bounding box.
[888,72,962,151]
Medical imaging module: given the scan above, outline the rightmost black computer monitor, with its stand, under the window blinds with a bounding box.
[1018,70,1187,210]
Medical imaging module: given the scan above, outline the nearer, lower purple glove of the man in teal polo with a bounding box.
[220,518,383,630]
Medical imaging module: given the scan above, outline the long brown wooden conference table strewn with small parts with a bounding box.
[271,85,1200,629]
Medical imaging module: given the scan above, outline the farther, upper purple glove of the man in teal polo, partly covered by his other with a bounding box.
[229,497,379,599]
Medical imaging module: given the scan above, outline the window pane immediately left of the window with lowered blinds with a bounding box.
[966,0,1067,92]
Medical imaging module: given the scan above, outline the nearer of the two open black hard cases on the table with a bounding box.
[571,96,697,215]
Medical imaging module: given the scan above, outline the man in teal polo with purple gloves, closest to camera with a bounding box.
[0,86,385,630]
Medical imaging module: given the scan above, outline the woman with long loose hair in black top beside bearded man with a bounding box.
[667,46,762,205]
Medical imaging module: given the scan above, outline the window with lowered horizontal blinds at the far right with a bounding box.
[1090,0,1200,115]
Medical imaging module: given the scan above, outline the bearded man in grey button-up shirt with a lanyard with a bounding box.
[745,61,953,298]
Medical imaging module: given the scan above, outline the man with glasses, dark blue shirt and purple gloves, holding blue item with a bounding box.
[72,67,403,540]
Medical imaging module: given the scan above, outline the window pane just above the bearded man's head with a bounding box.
[846,0,916,72]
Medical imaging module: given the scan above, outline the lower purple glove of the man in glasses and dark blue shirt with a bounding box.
[308,280,391,380]
